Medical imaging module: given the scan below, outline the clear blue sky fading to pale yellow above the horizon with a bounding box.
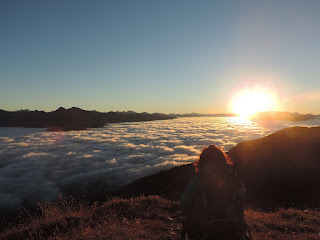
[0,0,320,114]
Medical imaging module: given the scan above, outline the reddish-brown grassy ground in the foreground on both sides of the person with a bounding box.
[0,196,320,240]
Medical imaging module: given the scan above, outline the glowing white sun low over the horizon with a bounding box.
[231,87,278,118]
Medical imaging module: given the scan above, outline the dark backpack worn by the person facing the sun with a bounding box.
[183,163,252,240]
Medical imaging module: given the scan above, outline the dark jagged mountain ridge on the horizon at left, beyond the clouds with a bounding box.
[0,107,173,131]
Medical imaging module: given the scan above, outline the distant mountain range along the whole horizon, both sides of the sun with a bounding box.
[0,107,317,131]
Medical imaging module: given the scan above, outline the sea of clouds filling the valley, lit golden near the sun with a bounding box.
[0,118,320,215]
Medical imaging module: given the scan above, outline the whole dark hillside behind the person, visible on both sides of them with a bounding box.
[120,127,320,207]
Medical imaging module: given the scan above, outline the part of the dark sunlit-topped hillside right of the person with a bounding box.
[229,127,320,206]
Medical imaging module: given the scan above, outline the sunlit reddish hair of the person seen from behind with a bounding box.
[193,145,233,173]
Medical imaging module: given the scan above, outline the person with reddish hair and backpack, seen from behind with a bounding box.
[180,145,251,240]
